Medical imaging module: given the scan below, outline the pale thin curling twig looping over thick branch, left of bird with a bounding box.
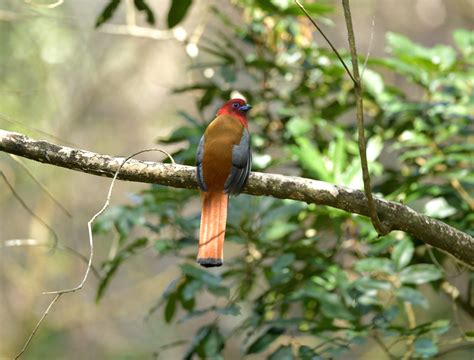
[14,148,175,359]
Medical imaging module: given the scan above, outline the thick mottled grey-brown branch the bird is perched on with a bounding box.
[0,130,474,266]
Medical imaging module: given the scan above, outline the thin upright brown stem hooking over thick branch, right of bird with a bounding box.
[342,0,390,235]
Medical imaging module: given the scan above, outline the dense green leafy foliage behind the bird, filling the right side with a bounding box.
[96,0,474,359]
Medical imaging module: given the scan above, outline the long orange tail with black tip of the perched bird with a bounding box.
[197,192,229,267]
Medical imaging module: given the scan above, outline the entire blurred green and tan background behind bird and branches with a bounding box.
[0,0,474,360]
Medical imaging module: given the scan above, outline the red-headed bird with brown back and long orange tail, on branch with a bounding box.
[196,99,252,267]
